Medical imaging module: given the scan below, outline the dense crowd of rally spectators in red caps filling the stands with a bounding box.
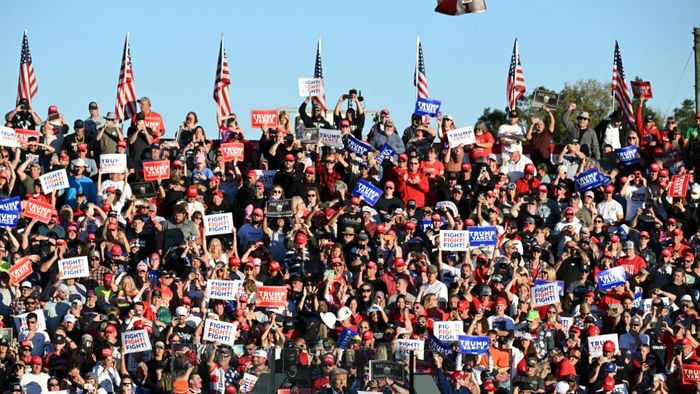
[0,89,700,394]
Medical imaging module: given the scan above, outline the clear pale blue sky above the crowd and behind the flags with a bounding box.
[0,0,700,137]
